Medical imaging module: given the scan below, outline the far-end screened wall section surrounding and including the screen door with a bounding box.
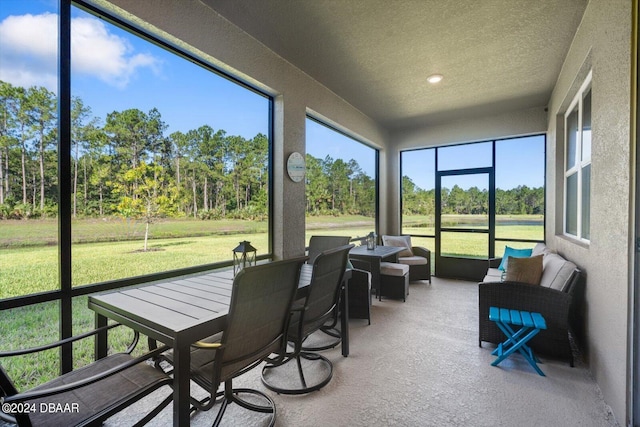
[401,135,546,258]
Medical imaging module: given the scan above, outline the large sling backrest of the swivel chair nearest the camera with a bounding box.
[214,257,307,384]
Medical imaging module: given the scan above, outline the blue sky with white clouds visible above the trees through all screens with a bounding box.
[0,0,544,188]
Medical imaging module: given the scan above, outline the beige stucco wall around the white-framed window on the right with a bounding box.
[546,0,632,424]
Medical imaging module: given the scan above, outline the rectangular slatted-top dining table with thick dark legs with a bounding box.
[88,270,350,426]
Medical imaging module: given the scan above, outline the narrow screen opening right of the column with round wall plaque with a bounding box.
[305,117,378,244]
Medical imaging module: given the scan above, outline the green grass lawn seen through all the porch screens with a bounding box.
[0,216,543,389]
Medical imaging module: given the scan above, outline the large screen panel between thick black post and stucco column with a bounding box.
[71,4,271,284]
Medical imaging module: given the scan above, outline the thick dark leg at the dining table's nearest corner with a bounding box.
[173,341,191,427]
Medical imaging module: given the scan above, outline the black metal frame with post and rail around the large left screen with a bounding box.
[0,0,274,373]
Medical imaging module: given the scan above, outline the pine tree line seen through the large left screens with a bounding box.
[0,81,269,219]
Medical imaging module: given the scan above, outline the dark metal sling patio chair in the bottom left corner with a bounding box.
[0,324,173,427]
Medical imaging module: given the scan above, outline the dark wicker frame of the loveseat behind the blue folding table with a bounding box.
[478,269,585,366]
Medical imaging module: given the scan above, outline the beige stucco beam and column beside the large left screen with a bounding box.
[92,0,386,258]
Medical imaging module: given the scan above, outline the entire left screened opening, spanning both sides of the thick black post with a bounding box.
[0,1,272,388]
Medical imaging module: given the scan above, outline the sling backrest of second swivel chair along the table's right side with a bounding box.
[302,245,354,336]
